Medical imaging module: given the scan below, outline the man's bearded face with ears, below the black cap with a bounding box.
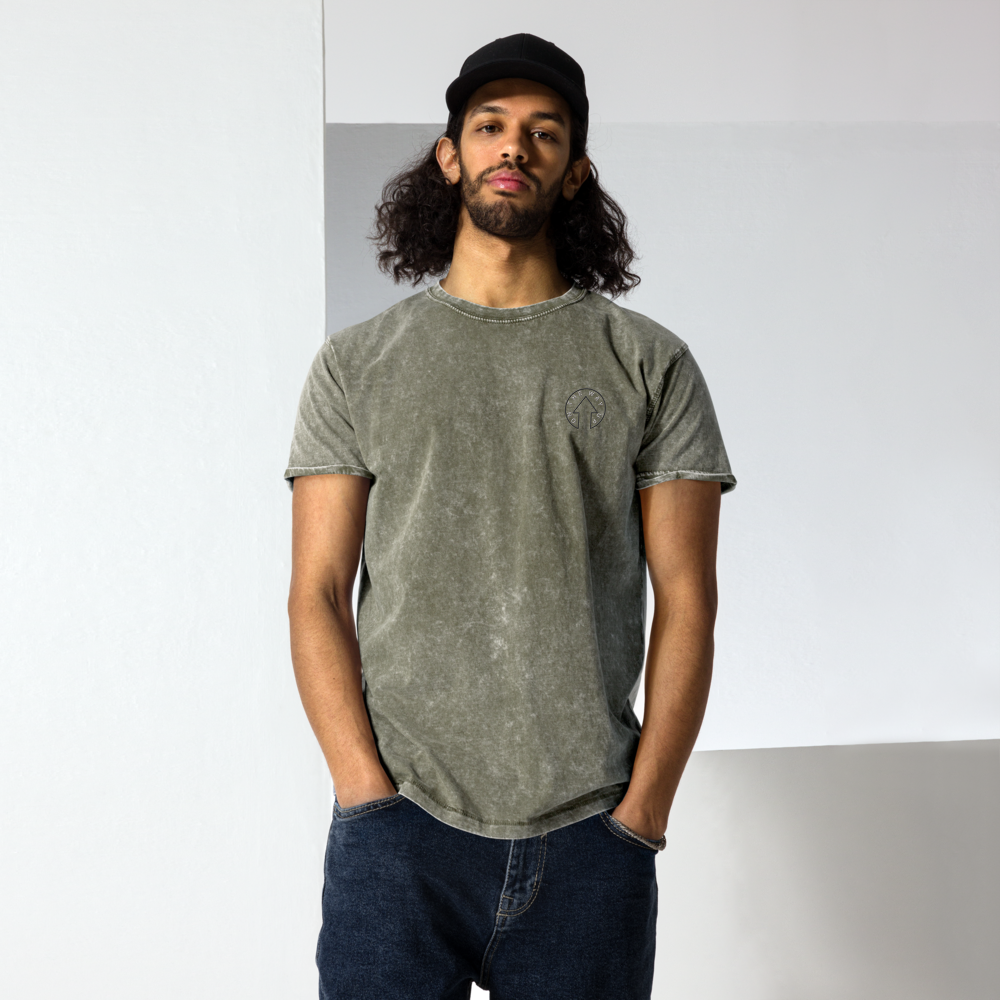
[437,79,590,239]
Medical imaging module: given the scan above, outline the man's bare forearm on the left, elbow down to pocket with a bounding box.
[288,592,395,804]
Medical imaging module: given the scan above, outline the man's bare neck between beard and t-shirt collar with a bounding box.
[441,205,570,309]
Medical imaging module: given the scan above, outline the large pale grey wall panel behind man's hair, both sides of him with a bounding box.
[327,124,1000,750]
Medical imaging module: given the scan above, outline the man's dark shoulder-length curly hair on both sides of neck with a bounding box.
[369,115,640,298]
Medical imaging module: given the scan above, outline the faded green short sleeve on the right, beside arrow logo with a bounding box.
[635,347,736,493]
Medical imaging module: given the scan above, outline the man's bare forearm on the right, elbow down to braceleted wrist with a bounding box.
[616,600,715,839]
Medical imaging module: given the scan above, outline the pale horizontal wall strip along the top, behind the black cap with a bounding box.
[326,0,1000,122]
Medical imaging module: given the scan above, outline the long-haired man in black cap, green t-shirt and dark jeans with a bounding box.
[285,34,736,1000]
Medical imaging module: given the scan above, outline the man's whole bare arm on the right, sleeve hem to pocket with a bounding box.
[612,479,722,840]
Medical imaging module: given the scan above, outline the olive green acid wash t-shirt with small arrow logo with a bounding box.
[285,285,736,838]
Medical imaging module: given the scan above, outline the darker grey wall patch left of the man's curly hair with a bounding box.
[325,124,444,333]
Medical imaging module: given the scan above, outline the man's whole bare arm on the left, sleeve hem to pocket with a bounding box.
[288,474,396,806]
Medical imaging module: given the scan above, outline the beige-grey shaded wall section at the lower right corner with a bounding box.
[654,740,1000,1000]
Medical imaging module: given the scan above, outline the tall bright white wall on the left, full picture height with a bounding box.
[0,0,329,1000]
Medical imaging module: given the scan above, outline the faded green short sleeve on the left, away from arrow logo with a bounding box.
[285,340,375,489]
